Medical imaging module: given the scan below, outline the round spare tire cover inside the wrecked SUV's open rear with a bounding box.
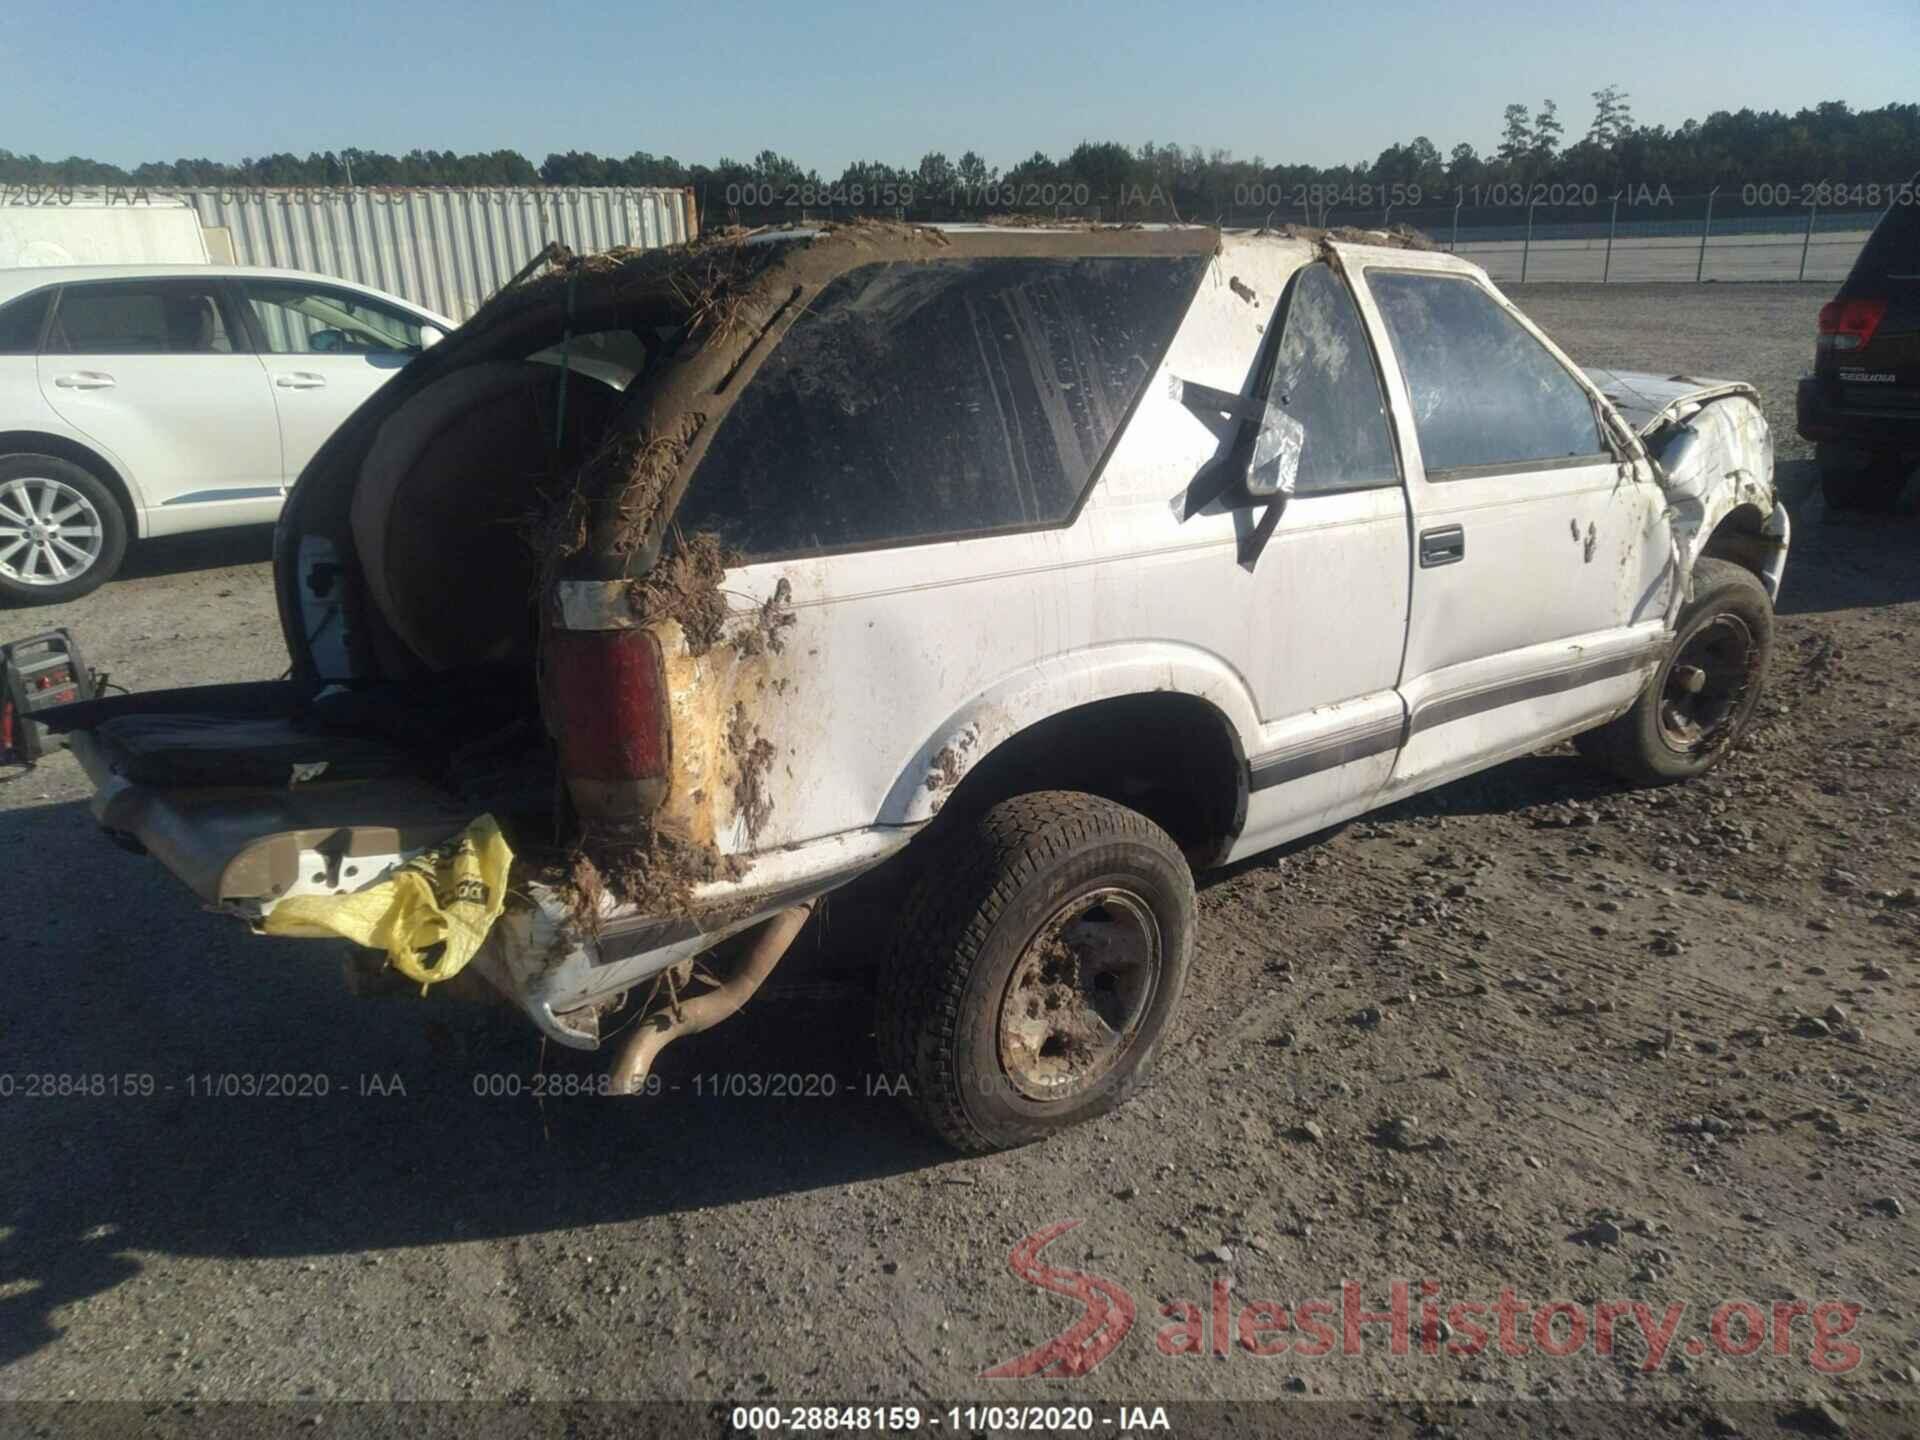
[349,361,620,670]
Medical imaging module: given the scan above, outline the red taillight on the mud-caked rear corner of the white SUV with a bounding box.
[545,630,672,822]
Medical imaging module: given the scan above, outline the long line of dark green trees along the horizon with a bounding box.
[0,95,1920,219]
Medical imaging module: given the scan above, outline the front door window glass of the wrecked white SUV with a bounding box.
[1367,271,1607,474]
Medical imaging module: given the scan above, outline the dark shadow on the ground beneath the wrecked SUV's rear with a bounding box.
[0,803,952,1365]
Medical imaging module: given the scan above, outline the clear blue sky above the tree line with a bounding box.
[0,0,1920,179]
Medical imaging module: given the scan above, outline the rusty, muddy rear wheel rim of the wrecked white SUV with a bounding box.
[995,887,1165,1102]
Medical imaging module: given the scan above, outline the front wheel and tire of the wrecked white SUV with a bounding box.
[1574,559,1774,785]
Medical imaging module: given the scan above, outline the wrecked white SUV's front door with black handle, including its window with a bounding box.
[1363,257,1672,791]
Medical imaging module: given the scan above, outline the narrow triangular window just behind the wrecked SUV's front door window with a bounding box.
[1267,261,1400,495]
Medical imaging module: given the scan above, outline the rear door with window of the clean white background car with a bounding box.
[35,278,280,534]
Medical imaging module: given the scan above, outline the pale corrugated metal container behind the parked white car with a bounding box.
[175,186,699,321]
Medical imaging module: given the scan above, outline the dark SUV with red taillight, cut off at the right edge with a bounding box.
[1799,192,1920,509]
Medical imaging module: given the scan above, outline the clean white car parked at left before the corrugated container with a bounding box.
[0,265,453,603]
